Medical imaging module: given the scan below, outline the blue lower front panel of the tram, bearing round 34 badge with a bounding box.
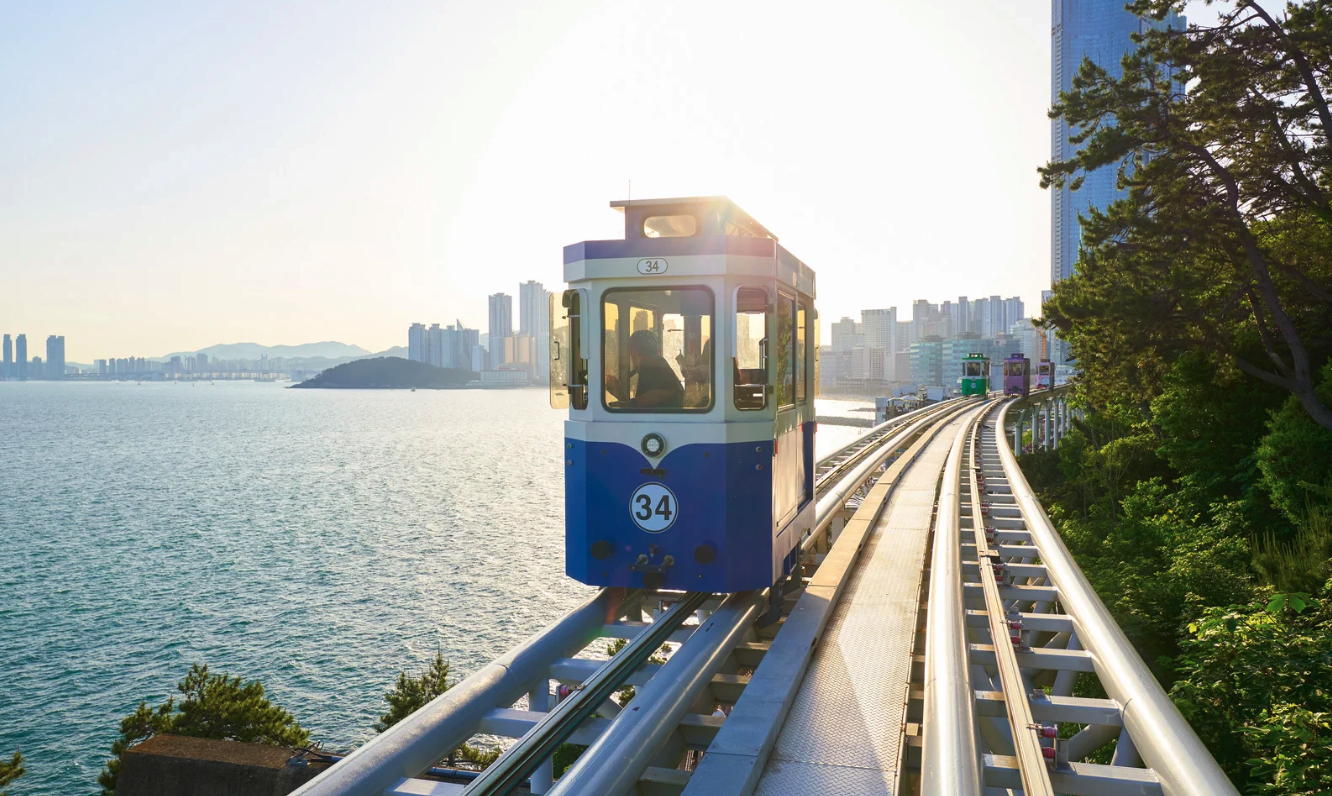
[565,439,795,592]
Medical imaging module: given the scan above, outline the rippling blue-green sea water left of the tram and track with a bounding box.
[0,382,866,796]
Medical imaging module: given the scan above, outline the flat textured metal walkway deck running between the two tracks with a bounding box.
[755,413,970,796]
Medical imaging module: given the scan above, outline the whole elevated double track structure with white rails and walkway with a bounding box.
[297,390,1236,796]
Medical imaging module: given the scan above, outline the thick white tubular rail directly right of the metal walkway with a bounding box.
[920,407,983,796]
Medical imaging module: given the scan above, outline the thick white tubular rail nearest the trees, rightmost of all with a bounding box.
[991,403,1239,796]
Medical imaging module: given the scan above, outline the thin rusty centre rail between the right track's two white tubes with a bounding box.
[966,406,1055,796]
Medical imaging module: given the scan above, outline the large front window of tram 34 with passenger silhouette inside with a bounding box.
[601,288,715,413]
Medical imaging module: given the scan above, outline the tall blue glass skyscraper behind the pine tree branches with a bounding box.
[1050,0,1187,284]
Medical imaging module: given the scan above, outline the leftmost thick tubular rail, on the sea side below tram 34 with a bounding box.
[294,588,634,796]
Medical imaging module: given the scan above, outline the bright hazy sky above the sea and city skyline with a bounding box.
[0,0,1225,362]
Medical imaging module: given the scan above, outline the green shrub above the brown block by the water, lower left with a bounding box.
[97,663,310,796]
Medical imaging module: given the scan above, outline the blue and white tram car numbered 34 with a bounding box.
[550,197,818,592]
